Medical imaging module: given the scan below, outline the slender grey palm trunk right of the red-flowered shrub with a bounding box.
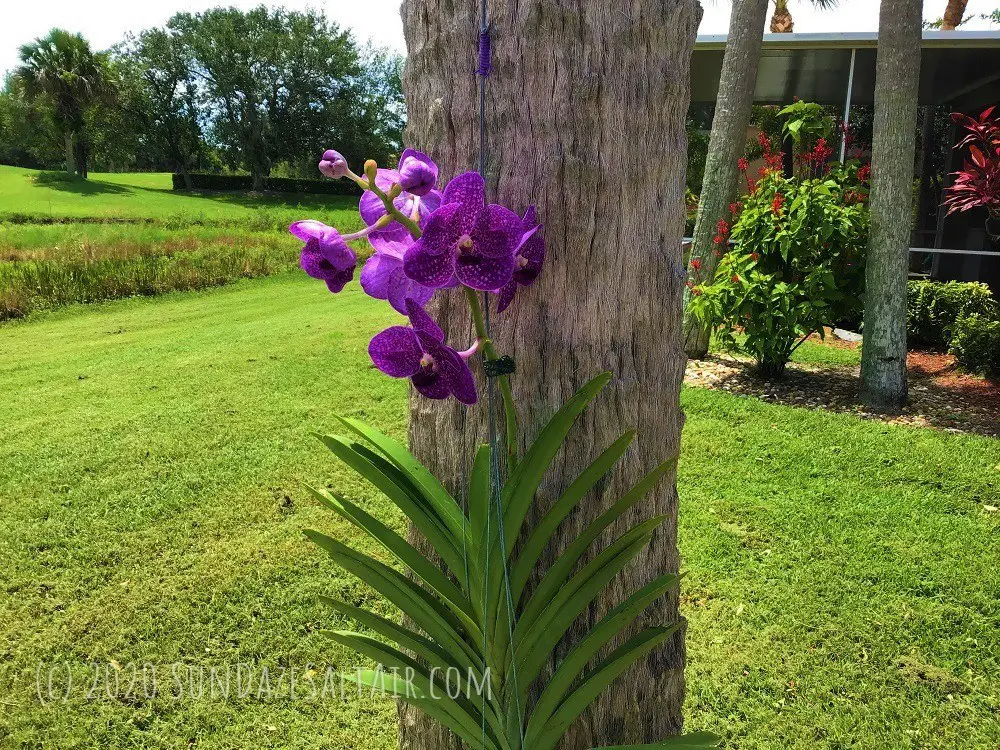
[861,0,923,411]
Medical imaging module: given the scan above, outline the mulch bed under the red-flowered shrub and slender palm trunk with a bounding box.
[685,339,1000,437]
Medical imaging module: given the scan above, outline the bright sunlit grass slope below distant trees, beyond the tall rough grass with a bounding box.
[0,166,357,223]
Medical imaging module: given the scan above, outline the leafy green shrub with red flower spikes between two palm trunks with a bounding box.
[688,166,868,378]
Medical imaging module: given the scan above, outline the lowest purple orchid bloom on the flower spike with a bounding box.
[368,300,478,406]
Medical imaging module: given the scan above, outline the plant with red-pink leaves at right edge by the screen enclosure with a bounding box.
[944,107,1000,228]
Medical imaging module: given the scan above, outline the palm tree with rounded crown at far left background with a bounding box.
[15,29,107,176]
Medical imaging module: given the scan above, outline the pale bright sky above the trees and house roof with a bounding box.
[0,0,1000,78]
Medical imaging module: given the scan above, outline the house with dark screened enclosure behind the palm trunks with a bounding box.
[691,31,1000,294]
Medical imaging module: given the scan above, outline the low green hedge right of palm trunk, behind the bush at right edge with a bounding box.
[906,281,1000,350]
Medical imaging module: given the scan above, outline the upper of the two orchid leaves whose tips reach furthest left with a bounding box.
[308,487,482,632]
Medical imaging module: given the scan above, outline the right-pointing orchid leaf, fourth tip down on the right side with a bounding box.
[514,516,664,683]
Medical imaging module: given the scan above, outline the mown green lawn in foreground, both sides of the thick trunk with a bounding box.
[0,276,1000,750]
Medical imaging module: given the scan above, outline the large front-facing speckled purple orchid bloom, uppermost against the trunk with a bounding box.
[403,172,524,291]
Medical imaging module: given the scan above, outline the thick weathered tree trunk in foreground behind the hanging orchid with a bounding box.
[399,0,701,750]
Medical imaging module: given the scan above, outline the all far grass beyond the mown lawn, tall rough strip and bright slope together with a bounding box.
[0,167,367,323]
